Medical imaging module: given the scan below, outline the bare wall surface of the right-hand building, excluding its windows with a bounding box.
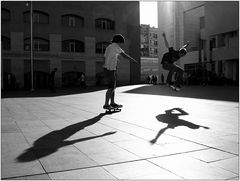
[158,1,239,83]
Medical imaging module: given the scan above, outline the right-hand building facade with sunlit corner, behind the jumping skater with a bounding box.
[158,1,239,84]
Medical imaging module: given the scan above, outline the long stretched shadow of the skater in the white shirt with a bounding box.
[16,113,116,162]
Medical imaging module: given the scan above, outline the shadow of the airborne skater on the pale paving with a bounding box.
[150,108,209,144]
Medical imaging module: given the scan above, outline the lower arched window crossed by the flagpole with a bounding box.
[24,37,49,51]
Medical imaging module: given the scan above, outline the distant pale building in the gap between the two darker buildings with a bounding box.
[141,24,159,81]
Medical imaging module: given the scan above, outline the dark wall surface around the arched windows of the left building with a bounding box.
[1,1,140,87]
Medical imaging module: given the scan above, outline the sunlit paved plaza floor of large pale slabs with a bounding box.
[1,85,239,180]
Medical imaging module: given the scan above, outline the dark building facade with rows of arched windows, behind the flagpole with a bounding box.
[1,1,140,88]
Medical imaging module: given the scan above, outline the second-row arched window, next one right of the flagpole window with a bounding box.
[62,39,84,52]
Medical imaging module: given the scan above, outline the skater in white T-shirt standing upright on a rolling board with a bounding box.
[103,34,137,109]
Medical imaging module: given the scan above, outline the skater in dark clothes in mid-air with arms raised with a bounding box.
[161,33,189,90]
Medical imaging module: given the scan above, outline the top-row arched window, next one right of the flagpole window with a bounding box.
[62,14,84,27]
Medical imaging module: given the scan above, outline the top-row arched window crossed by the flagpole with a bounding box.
[23,10,49,24]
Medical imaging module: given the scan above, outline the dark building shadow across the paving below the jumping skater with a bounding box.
[125,85,239,102]
